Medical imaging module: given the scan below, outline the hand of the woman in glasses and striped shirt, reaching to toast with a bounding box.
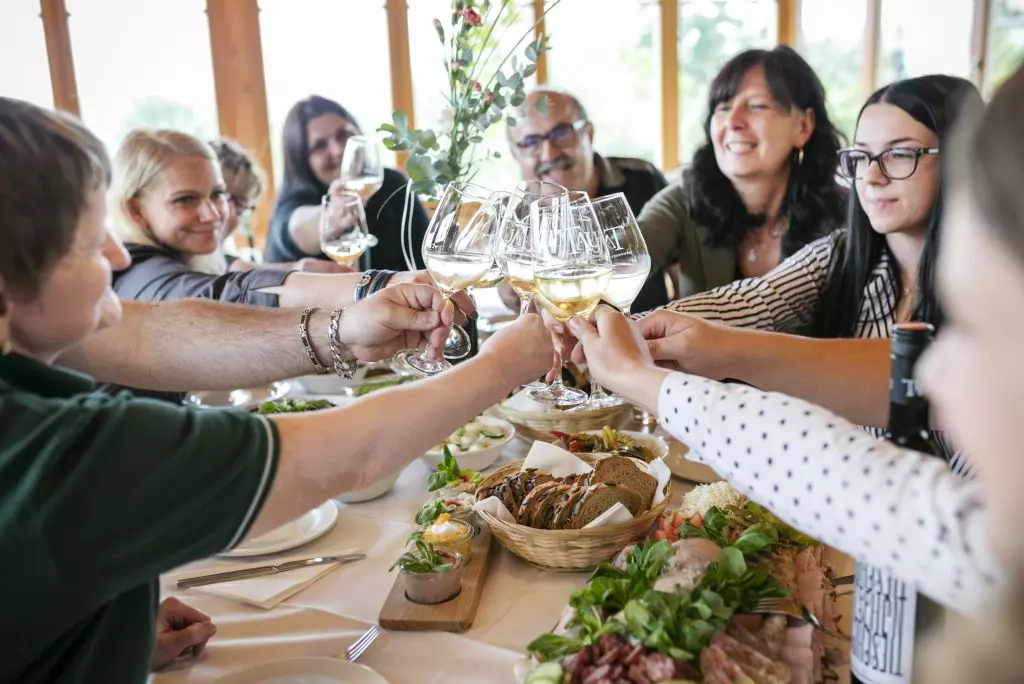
[639,310,744,380]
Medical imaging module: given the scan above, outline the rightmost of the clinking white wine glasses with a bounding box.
[587,193,650,408]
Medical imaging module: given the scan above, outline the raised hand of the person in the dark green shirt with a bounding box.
[479,313,555,387]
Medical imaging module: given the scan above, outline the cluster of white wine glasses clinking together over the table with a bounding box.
[393,180,650,407]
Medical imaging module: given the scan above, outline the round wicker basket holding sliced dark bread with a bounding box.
[476,454,672,572]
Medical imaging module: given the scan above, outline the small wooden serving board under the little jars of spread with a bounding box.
[378,525,494,632]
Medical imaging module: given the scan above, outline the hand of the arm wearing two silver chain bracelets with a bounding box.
[338,285,466,361]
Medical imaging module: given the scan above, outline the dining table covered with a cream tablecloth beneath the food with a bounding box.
[151,296,852,684]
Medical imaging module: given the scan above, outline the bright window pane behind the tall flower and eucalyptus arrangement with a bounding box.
[409,0,536,187]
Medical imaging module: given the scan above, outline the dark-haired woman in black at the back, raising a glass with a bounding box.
[266,95,429,270]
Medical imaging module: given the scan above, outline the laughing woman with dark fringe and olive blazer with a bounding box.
[637,46,844,297]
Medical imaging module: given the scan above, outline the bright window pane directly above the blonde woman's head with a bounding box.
[68,0,217,153]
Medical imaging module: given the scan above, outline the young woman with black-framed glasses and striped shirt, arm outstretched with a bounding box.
[641,76,981,428]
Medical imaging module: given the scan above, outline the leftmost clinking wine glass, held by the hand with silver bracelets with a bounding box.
[393,181,503,377]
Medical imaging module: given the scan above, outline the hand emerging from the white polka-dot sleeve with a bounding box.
[568,304,665,408]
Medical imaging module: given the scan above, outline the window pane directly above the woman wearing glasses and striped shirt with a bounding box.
[877,0,974,87]
